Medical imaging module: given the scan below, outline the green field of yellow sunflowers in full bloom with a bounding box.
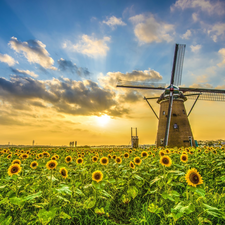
[0,146,225,225]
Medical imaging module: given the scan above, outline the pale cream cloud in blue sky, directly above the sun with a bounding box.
[63,34,110,58]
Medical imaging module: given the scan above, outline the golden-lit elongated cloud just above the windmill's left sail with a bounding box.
[99,69,162,89]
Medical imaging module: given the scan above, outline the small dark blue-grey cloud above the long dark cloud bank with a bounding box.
[57,58,90,77]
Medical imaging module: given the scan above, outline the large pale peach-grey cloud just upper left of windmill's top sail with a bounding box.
[129,14,174,43]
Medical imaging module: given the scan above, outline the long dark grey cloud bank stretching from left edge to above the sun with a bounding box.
[0,76,129,117]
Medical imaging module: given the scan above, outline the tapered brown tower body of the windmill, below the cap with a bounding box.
[156,98,195,148]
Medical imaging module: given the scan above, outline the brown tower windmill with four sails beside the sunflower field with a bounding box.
[117,44,225,147]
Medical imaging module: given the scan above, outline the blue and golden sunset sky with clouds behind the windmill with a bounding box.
[0,0,225,145]
